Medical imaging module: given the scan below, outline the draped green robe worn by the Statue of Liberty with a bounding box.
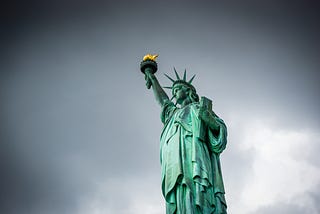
[160,101,227,214]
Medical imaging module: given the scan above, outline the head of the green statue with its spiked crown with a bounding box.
[165,69,199,104]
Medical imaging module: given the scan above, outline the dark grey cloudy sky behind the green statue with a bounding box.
[0,0,320,214]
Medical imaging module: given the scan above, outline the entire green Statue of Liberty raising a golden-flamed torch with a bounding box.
[141,55,227,214]
